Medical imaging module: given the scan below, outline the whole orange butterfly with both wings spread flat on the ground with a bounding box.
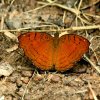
[18,32,90,71]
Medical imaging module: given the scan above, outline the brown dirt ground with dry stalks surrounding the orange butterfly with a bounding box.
[0,0,100,100]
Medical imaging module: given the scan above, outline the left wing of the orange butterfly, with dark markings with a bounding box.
[18,32,53,70]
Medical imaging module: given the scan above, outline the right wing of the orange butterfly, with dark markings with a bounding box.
[55,34,90,71]
